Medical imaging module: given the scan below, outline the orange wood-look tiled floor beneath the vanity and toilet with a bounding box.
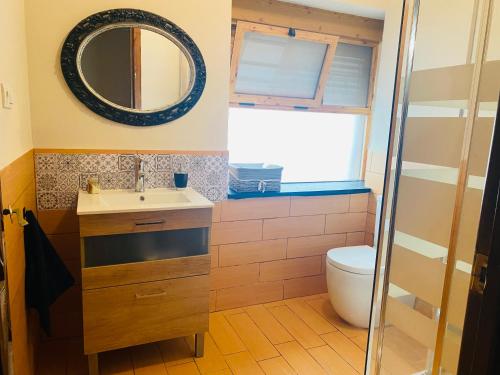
[38,295,367,375]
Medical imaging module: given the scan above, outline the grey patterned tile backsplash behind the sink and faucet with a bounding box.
[35,152,228,210]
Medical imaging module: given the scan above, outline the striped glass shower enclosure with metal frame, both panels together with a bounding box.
[371,0,500,375]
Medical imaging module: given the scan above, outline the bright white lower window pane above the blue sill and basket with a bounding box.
[229,108,365,182]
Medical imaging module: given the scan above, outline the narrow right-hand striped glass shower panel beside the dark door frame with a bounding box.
[436,0,500,375]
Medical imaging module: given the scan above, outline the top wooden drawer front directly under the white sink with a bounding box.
[79,208,212,237]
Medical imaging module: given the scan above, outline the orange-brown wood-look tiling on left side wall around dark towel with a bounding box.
[0,151,38,375]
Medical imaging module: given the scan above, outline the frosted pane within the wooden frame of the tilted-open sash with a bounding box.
[235,32,327,99]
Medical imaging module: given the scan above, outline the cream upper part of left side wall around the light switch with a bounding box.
[0,0,33,169]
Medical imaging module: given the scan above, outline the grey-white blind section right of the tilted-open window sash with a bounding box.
[323,43,373,107]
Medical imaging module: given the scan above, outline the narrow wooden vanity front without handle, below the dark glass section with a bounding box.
[82,254,210,290]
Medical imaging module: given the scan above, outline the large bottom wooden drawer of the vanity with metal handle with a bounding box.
[83,275,209,354]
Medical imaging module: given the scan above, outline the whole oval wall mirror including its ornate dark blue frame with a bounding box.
[61,9,206,126]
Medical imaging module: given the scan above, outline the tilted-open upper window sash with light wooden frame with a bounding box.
[231,22,339,107]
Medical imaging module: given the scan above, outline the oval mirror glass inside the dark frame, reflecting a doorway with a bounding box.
[79,26,193,111]
